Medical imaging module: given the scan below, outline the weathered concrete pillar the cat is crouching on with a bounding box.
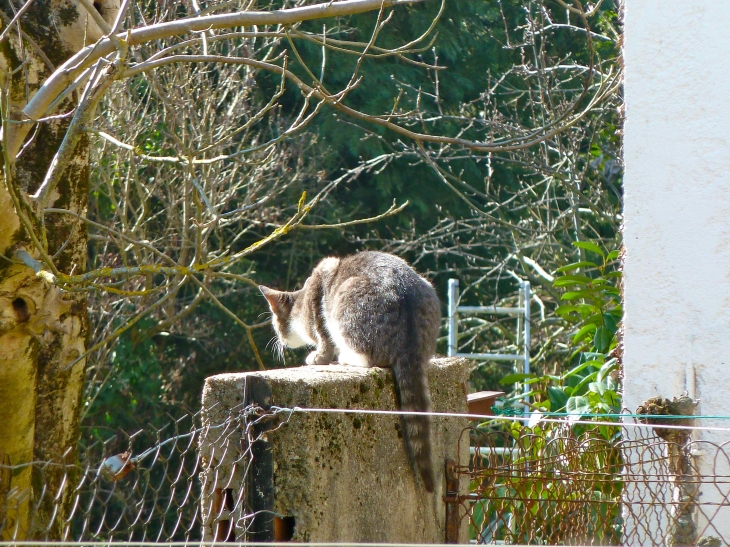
[200,359,469,543]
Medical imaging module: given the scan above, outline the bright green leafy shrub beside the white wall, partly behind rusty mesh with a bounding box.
[478,247,623,545]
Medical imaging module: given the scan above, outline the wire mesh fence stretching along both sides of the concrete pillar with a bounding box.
[0,405,730,545]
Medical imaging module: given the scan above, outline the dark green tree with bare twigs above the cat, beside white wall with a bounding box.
[278,0,623,389]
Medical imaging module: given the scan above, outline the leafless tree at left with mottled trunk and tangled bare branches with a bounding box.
[0,0,426,539]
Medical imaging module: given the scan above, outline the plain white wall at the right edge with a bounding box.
[624,0,730,541]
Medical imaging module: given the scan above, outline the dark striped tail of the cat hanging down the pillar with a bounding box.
[393,351,435,492]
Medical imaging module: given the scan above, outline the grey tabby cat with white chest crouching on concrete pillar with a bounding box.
[259,251,441,492]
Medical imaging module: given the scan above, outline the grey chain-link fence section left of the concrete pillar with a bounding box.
[0,405,290,542]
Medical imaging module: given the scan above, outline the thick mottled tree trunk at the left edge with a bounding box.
[0,0,114,540]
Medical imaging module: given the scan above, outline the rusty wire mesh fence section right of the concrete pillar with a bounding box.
[448,421,730,545]
